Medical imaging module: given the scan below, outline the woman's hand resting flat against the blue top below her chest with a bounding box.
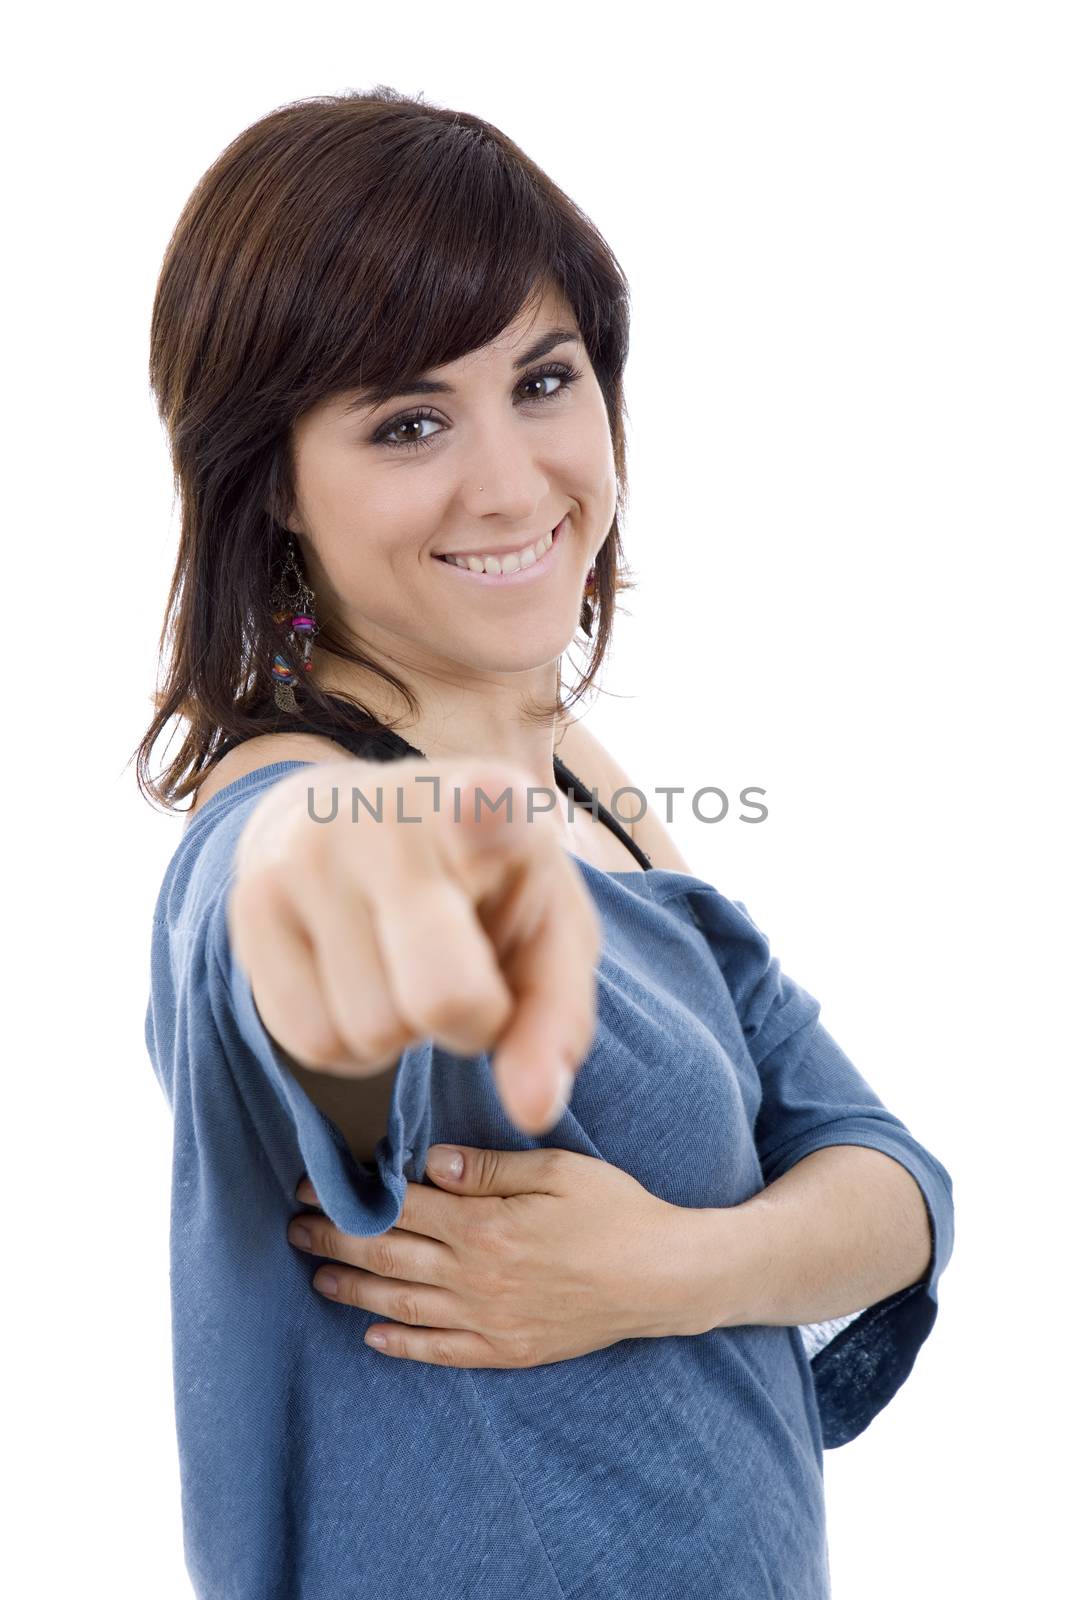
[288,1146,691,1368]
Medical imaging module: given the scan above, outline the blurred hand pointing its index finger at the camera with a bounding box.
[227,757,600,1133]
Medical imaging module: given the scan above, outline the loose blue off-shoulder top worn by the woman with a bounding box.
[146,760,953,1600]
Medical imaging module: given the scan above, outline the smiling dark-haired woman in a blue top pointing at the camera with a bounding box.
[139,90,953,1600]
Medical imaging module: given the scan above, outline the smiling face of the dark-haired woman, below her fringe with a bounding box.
[290,291,616,688]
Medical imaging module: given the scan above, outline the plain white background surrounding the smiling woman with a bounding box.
[2,0,1067,1600]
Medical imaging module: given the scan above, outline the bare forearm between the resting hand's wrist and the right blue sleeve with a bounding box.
[683,1144,933,1331]
